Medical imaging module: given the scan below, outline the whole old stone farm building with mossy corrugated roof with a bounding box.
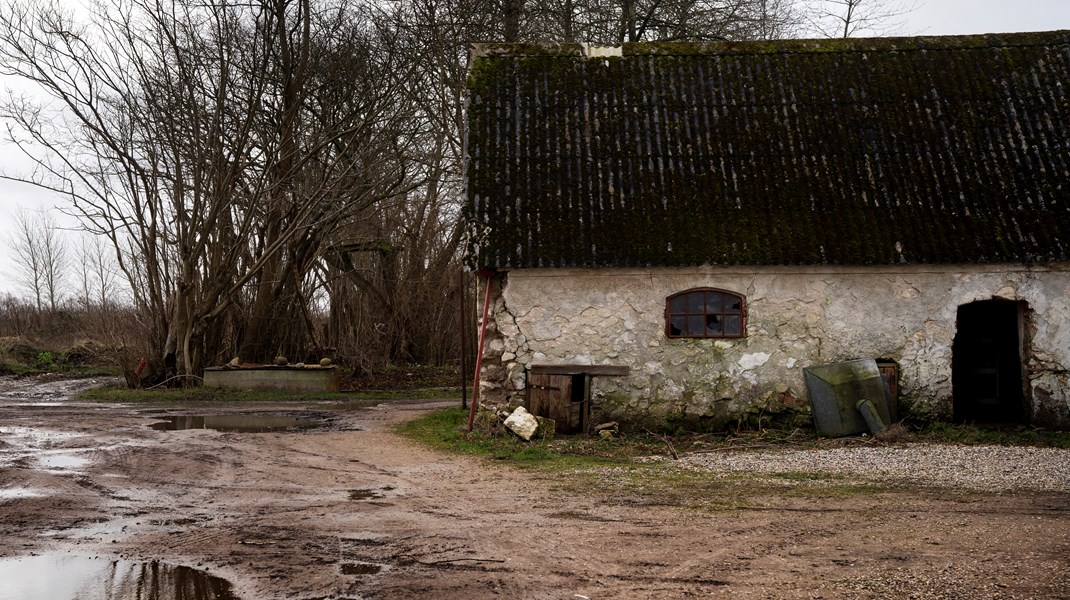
[467,31,1070,428]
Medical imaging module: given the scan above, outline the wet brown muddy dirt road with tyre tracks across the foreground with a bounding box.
[0,380,1070,600]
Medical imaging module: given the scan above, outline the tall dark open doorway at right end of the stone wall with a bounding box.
[951,301,1026,422]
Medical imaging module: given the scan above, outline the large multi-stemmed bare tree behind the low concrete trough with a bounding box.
[0,0,413,373]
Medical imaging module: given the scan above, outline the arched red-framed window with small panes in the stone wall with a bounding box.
[666,288,747,338]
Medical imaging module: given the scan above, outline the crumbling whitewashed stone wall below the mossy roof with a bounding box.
[482,263,1070,427]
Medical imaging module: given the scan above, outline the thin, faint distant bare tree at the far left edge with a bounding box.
[6,211,67,312]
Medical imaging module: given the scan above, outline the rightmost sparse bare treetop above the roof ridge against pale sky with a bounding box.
[806,0,918,37]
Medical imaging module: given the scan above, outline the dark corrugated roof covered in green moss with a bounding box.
[464,31,1070,268]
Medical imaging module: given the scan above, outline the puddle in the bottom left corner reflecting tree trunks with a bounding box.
[0,555,238,600]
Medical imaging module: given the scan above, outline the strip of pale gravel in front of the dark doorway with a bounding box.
[677,444,1070,492]
